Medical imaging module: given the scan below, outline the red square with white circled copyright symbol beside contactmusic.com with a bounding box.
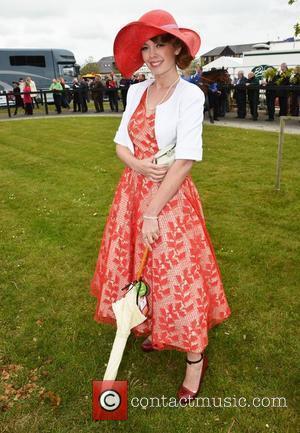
[92,380,128,421]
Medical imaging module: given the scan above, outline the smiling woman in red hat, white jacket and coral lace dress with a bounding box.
[91,10,231,401]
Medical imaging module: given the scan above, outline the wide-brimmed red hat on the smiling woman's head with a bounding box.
[114,9,201,77]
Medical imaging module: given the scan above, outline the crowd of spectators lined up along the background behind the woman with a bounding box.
[8,63,300,121]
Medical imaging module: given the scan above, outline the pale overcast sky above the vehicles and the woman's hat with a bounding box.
[0,0,300,64]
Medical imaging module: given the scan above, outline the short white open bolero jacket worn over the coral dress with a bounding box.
[114,78,205,161]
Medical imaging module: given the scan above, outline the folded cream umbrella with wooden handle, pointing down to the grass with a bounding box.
[103,247,150,380]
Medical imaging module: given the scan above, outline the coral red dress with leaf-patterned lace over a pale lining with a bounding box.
[90,87,231,352]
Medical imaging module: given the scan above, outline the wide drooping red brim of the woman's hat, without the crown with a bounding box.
[113,21,201,77]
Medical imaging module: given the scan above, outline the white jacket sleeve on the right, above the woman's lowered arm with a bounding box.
[175,84,205,161]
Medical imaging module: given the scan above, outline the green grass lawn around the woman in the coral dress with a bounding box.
[0,118,300,433]
